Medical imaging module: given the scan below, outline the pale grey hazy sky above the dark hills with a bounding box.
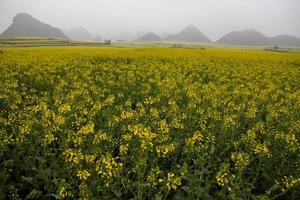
[0,0,300,40]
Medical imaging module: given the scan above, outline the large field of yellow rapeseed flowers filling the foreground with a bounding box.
[0,47,300,199]
